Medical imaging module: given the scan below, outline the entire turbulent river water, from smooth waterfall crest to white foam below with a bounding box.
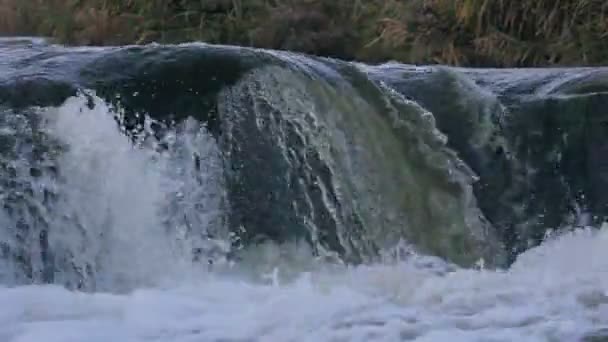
[0,39,608,342]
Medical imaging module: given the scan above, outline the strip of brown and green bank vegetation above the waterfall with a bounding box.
[0,0,608,66]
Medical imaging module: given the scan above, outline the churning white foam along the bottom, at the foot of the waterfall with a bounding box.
[0,229,608,342]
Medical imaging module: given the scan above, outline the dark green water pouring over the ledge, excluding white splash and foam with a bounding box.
[0,39,608,288]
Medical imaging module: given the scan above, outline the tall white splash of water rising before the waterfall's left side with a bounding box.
[0,96,226,291]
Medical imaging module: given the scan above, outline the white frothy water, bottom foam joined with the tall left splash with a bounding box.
[0,93,608,342]
